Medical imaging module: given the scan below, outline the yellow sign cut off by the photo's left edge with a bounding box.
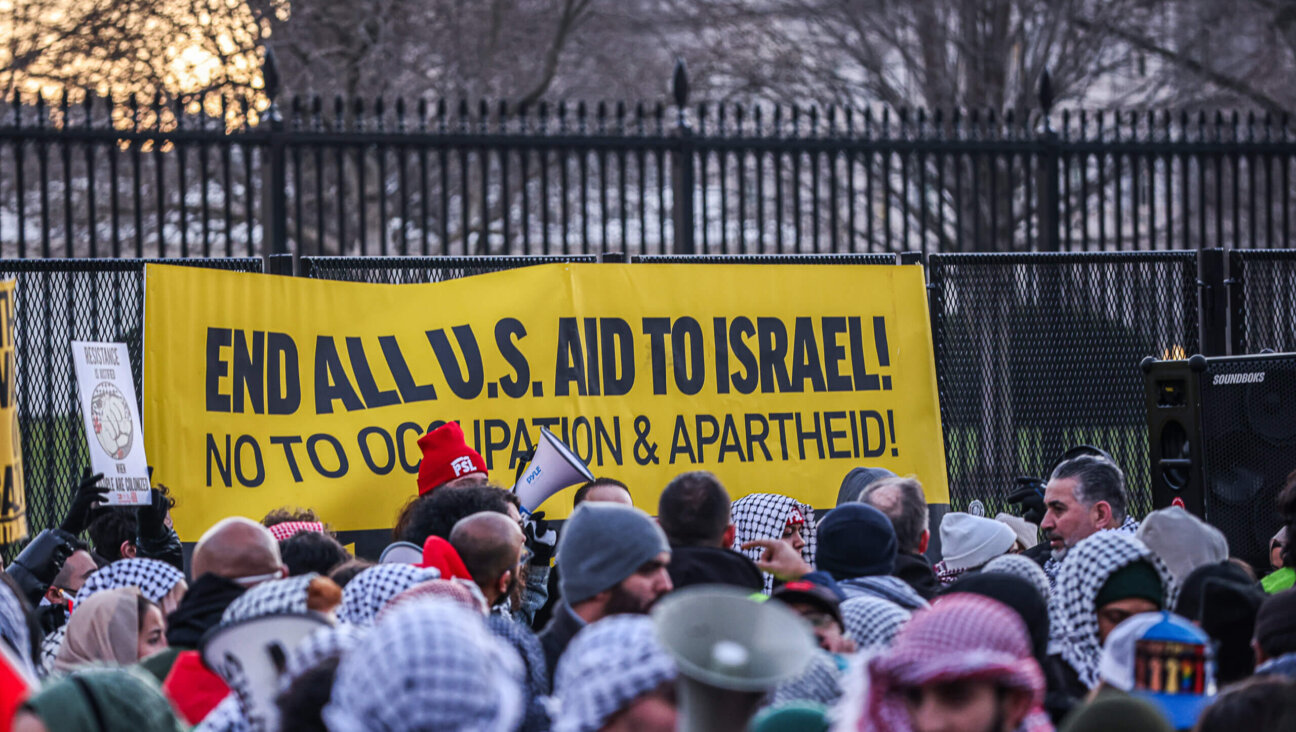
[0,280,27,544]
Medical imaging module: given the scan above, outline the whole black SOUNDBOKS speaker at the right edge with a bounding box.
[1142,354,1296,571]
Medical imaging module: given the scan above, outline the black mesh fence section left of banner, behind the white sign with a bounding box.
[0,258,262,560]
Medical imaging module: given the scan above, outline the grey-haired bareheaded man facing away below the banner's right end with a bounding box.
[859,475,941,600]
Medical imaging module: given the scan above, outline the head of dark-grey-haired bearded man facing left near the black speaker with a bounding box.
[1039,455,1138,584]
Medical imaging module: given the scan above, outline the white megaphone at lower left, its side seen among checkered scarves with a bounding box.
[202,614,329,732]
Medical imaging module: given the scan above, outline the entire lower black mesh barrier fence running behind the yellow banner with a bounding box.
[0,250,1296,551]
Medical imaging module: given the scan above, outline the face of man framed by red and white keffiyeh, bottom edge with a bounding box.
[899,679,1029,732]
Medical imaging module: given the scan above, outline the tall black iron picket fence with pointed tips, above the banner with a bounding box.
[0,70,1296,258]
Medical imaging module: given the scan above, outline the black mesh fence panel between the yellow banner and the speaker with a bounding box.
[928,251,1199,516]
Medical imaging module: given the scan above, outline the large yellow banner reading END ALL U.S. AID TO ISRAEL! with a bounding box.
[144,264,949,540]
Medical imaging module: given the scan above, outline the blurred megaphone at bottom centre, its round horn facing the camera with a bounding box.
[652,584,816,732]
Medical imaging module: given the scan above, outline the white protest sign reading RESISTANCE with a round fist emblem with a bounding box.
[73,341,150,505]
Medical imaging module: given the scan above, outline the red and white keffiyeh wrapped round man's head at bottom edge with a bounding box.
[858,593,1054,732]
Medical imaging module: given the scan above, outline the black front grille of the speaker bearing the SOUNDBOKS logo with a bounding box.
[1201,355,1296,569]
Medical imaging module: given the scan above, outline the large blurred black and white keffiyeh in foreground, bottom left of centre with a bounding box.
[324,600,524,732]
